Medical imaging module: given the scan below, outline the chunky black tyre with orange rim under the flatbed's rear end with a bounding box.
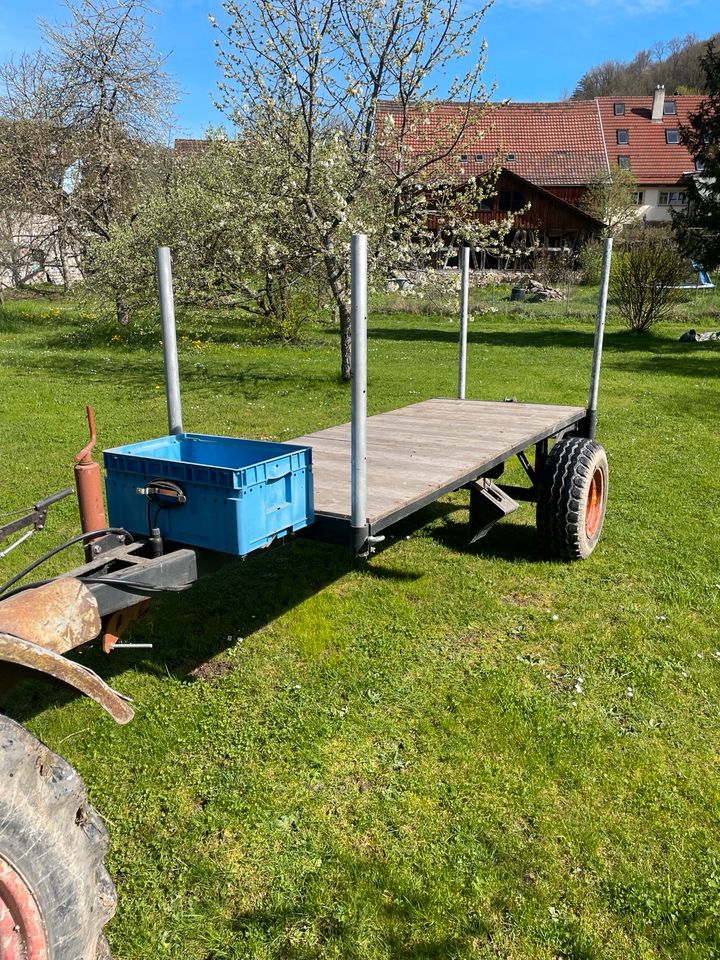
[537,437,608,560]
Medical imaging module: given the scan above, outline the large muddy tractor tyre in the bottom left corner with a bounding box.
[0,715,117,960]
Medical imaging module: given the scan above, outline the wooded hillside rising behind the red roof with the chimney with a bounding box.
[572,33,720,100]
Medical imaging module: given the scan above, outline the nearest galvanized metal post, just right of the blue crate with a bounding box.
[350,233,368,552]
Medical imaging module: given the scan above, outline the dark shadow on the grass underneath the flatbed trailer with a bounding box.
[5,501,539,722]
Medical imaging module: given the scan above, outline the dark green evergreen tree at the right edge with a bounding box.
[673,41,720,270]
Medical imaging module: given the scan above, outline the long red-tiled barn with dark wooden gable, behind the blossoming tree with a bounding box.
[377,101,607,251]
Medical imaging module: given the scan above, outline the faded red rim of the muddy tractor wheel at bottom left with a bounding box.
[0,857,50,960]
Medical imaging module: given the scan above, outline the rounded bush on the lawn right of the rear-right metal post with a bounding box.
[610,236,685,333]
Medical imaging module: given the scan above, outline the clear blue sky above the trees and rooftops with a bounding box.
[0,0,708,137]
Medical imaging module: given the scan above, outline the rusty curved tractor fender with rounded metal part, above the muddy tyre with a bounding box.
[0,577,133,723]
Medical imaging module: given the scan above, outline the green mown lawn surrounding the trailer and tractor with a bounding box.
[0,292,720,960]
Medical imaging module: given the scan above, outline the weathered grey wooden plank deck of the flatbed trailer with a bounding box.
[289,399,586,539]
